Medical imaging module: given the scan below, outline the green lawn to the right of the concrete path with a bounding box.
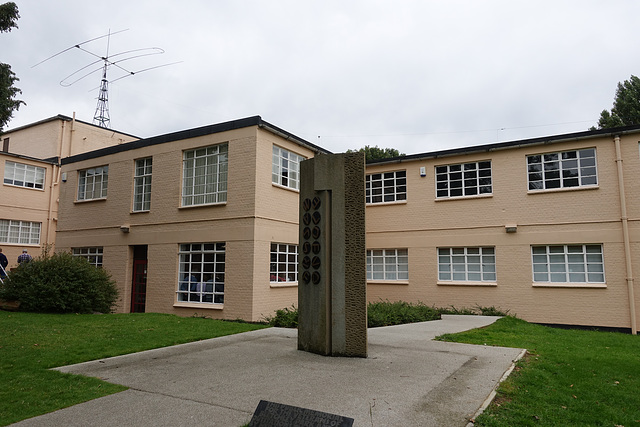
[438,317,640,427]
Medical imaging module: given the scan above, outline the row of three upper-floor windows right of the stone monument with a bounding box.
[365,148,598,203]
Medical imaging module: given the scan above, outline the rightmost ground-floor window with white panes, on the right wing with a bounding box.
[531,245,604,283]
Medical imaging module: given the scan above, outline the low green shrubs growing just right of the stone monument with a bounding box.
[367,301,440,328]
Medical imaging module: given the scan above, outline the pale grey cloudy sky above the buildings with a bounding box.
[0,0,640,154]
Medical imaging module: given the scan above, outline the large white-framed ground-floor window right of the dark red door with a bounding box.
[178,243,225,304]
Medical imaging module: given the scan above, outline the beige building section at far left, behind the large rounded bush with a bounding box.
[0,115,137,268]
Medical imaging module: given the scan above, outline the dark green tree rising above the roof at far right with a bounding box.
[598,75,640,129]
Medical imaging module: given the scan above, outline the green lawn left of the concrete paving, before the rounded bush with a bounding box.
[0,311,265,426]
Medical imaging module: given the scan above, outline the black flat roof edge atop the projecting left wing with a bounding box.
[62,116,331,165]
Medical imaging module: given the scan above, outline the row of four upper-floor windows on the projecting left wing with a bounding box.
[76,144,304,212]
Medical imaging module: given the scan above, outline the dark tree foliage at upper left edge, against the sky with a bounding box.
[0,2,26,134]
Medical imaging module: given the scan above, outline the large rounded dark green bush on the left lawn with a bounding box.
[0,252,118,313]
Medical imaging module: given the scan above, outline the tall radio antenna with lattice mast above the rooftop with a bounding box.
[31,29,179,128]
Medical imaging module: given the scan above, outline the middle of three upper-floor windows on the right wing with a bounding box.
[436,160,493,198]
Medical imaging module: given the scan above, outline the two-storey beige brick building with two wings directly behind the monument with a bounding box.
[26,117,640,332]
